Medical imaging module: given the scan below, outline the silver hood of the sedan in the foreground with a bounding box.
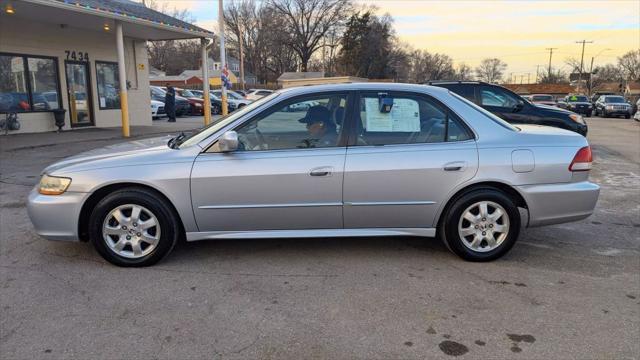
[43,135,174,174]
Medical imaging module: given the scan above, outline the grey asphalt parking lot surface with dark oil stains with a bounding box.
[0,118,640,359]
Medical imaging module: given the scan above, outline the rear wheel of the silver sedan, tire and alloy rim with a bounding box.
[438,188,520,262]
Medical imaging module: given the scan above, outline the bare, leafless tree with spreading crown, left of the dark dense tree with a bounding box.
[268,0,351,71]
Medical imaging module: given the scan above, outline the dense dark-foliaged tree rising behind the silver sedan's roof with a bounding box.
[337,10,393,79]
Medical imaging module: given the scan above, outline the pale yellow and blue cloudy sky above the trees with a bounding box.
[149,0,640,79]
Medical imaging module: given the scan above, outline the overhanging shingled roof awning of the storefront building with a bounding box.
[13,0,214,41]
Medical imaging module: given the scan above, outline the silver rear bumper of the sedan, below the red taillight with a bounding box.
[518,181,600,227]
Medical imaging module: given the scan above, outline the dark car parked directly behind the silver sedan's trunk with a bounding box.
[428,81,587,136]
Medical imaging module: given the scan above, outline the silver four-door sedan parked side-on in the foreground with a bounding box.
[28,83,599,266]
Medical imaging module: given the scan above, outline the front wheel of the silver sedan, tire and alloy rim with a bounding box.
[89,188,182,267]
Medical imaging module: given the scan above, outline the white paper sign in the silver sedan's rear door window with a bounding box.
[364,98,420,132]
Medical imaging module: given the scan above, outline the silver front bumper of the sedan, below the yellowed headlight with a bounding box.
[27,188,89,241]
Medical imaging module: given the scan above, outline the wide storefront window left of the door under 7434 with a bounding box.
[0,54,60,112]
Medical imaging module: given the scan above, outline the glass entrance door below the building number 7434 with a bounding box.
[64,61,94,127]
